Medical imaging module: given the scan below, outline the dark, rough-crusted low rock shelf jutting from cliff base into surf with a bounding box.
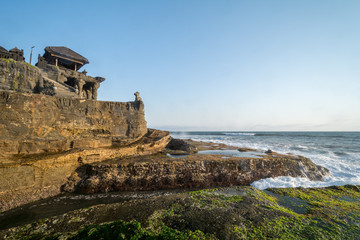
[63,143,330,194]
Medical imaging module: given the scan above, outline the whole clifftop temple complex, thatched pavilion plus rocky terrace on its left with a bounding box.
[0,46,105,100]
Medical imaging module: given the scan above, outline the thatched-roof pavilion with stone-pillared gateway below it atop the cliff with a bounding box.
[36,46,105,100]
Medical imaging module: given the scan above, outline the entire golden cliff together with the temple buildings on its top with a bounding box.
[0,55,158,211]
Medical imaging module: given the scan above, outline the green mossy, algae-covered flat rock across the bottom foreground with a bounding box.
[0,186,360,239]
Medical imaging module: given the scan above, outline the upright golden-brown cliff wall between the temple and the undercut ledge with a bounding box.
[0,91,147,156]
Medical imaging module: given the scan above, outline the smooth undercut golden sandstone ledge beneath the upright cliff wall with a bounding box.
[0,129,170,211]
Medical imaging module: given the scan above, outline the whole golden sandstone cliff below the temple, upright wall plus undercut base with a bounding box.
[0,88,152,211]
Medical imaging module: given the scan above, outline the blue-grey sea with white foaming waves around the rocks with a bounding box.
[171,132,360,189]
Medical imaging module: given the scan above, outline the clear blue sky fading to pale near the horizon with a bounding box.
[0,0,360,131]
